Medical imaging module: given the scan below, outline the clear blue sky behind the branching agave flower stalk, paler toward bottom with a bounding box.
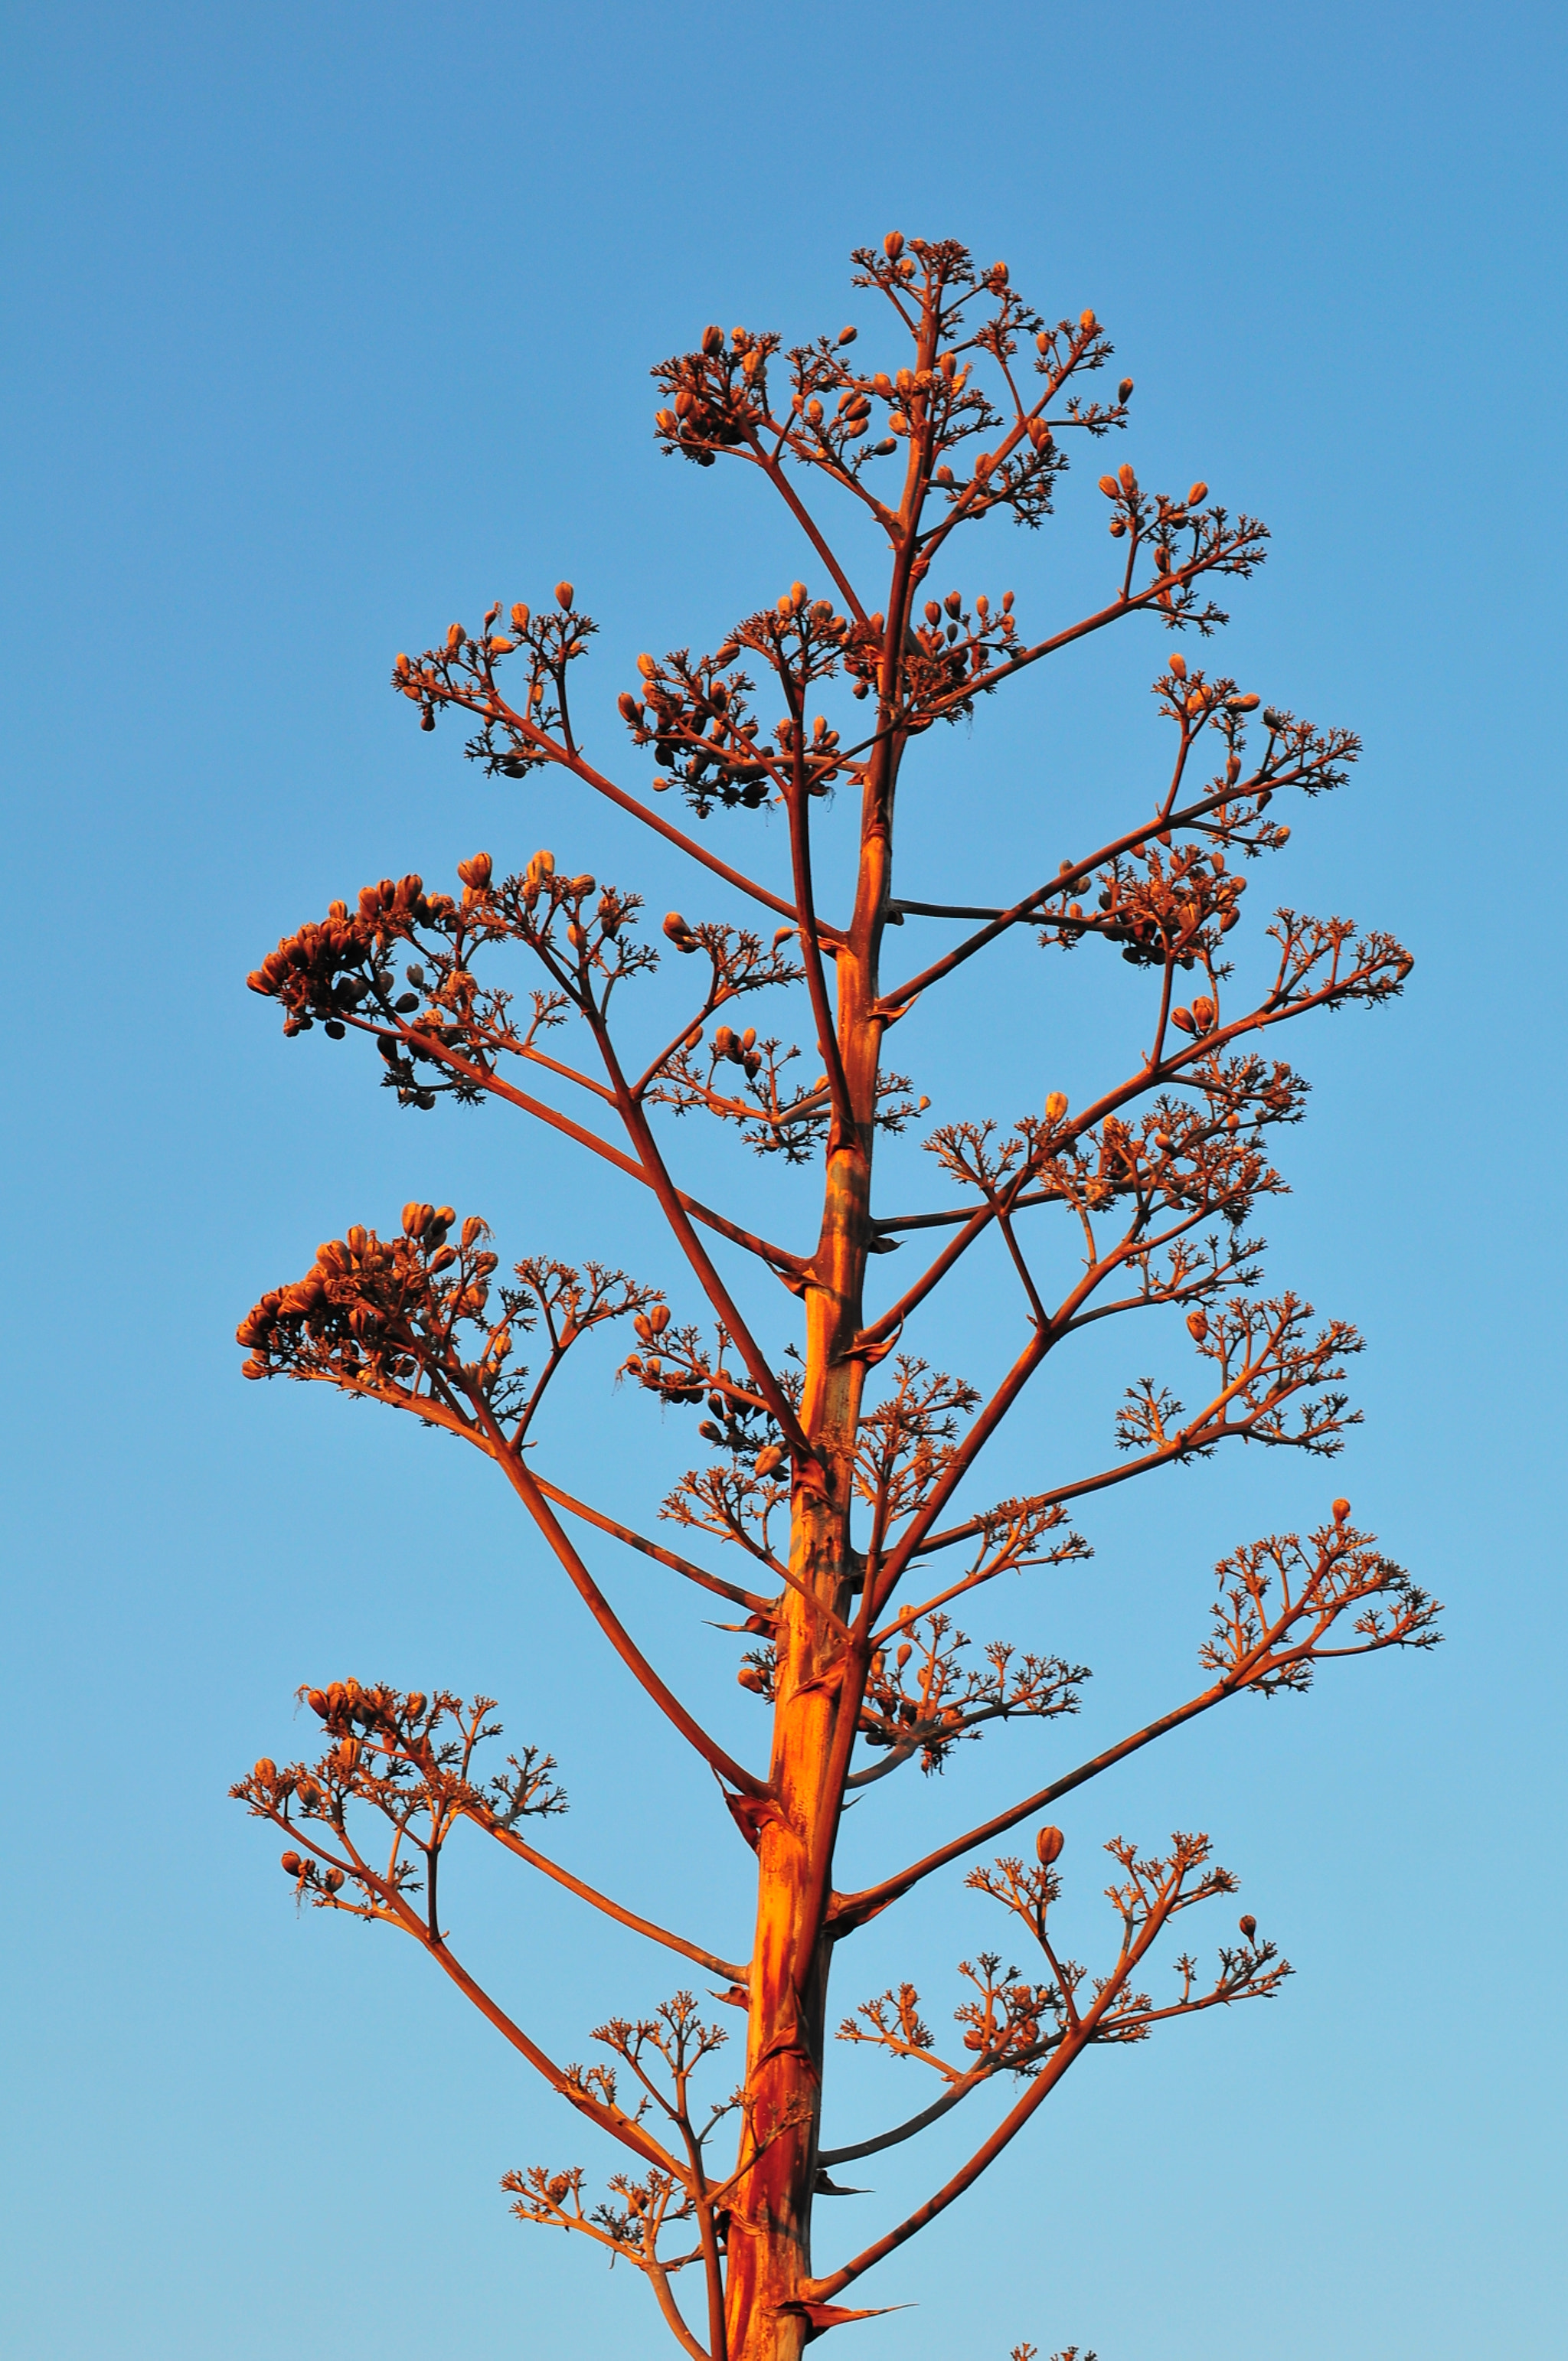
[0,0,1566,2361]
